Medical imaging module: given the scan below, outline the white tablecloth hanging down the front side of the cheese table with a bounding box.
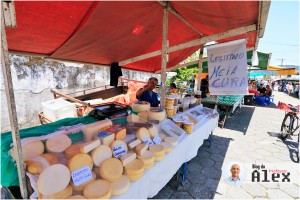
[112,118,218,199]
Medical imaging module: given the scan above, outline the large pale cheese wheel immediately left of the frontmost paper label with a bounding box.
[37,164,71,195]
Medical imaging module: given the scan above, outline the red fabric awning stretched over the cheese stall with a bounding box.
[6,1,259,72]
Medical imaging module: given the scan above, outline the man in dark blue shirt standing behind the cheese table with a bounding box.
[136,77,159,107]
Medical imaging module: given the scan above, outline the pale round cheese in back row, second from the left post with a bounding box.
[46,135,72,153]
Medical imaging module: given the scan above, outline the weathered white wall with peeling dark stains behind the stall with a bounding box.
[0,55,160,132]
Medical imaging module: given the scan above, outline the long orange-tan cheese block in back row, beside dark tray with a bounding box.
[82,120,112,144]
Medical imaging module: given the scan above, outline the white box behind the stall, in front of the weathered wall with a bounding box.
[41,99,77,122]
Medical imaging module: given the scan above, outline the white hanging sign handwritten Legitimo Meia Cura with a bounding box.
[207,39,248,95]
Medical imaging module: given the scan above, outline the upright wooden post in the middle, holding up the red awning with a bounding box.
[160,3,169,108]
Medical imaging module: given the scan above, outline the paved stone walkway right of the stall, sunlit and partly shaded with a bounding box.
[154,92,299,199]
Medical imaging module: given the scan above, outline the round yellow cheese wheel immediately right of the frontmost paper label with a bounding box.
[100,158,123,182]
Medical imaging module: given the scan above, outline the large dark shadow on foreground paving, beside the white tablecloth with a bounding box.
[153,135,231,199]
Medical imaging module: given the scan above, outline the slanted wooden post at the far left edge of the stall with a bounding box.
[0,2,28,199]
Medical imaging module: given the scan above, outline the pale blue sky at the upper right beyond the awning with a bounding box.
[257,1,300,65]
